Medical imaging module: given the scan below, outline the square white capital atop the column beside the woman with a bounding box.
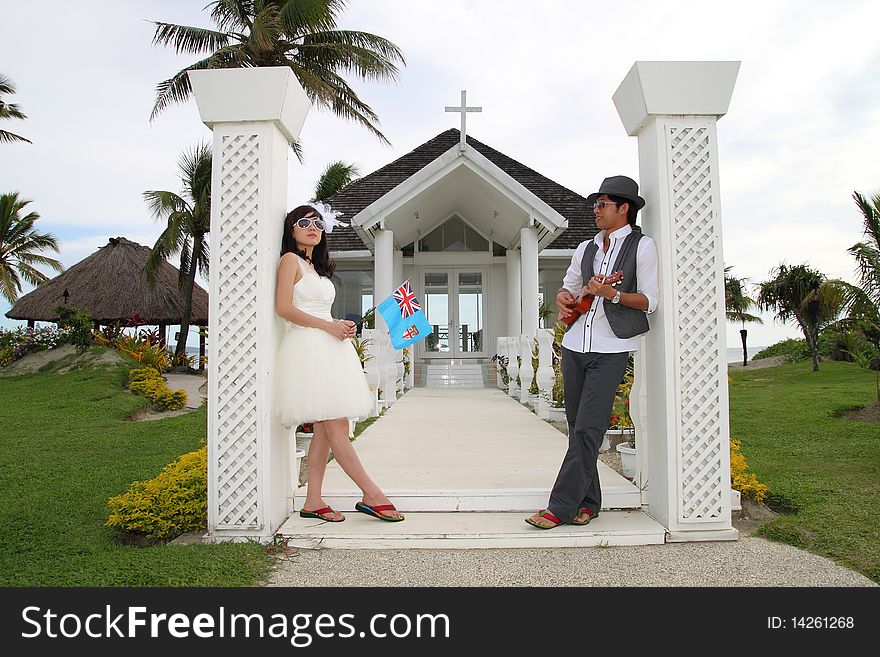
[188,66,311,142]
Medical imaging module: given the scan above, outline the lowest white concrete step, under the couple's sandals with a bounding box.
[278,509,666,550]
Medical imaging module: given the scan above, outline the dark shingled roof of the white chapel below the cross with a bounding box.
[327,128,598,251]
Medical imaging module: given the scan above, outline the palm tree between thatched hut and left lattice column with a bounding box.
[144,143,211,361]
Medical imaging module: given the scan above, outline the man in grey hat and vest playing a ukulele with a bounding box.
[526,176,660,529]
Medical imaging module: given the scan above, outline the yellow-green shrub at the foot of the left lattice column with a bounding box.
[107,447,208,539]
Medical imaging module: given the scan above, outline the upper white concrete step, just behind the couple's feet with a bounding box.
[293,478,641,513]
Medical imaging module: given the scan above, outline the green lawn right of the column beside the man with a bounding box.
[730,361,880,582]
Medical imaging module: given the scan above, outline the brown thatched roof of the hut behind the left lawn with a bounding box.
[6,237,208,326]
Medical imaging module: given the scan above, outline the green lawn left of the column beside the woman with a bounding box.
[0,348,271,586]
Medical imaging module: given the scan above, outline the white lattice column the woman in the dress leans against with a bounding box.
[189,67,309,540]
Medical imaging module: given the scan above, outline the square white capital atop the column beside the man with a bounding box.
[613,62,740,136]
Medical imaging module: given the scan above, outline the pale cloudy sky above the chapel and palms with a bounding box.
[0,0,880,347]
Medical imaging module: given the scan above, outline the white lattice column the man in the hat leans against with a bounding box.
[614,62,739,541]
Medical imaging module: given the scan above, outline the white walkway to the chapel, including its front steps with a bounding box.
[280,388,665,548]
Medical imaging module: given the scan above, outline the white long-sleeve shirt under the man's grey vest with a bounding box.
[562,224,660,354]
